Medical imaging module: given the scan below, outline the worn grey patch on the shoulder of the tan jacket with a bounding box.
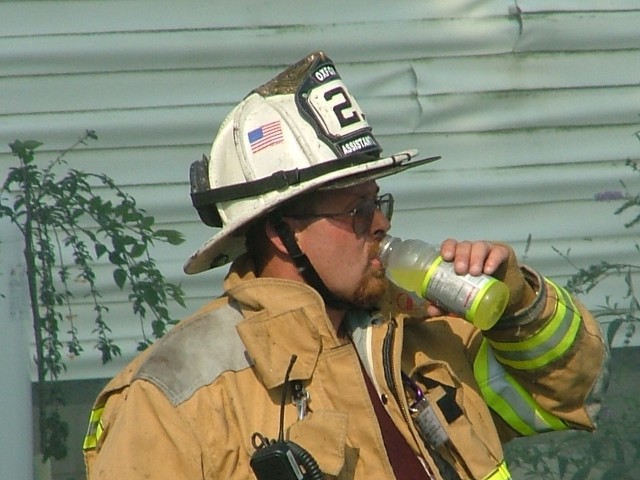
[132,303,251,406]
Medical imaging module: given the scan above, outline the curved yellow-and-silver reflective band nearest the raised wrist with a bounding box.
[489,282,581,370]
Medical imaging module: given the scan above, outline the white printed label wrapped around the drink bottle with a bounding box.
[421,257,496,322]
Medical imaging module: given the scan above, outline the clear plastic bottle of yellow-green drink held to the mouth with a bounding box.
[379,235,509,330]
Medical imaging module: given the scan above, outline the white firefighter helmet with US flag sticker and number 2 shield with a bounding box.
[184,52,439,274]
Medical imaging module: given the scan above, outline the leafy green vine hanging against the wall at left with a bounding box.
[0,130,185,461]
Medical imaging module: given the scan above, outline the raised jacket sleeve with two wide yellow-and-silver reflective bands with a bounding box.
[473,267,608,440]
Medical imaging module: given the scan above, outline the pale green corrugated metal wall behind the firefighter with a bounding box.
[0,0,640,378]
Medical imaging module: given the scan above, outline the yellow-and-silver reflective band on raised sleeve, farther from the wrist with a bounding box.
[473,339,567,436]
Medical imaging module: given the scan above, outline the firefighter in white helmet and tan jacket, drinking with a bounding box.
[84,52,607,480]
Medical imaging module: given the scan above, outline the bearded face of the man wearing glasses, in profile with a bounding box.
[290,181,391,307]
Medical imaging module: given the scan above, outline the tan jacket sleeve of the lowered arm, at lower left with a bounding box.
[84,380,203,480]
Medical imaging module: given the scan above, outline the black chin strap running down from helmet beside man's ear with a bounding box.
[269,210,349,309]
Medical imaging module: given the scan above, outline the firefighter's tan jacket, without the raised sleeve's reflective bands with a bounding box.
[85,261,606,480]
